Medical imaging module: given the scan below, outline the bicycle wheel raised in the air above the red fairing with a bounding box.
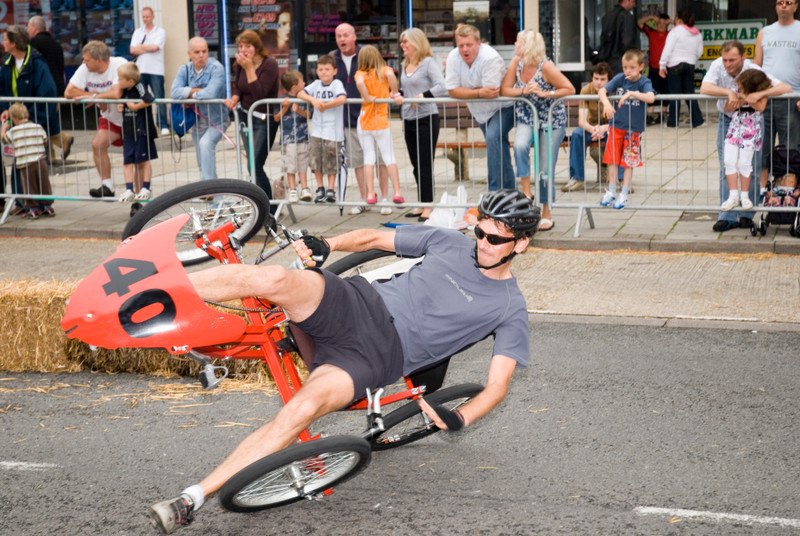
[122,179,271,266]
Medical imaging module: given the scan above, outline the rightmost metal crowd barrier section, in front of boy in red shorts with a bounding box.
[538,94,800,237]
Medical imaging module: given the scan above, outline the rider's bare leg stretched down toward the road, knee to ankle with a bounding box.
[194,365,354,497]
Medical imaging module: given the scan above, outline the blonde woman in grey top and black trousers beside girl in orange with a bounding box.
[400,28,448,221]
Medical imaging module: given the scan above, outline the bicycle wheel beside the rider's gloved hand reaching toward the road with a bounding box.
[368,383,483,450]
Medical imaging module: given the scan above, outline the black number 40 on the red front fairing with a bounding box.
[103,259,178,338]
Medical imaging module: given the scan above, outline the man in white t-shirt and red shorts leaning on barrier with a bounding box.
[64,41,127,198]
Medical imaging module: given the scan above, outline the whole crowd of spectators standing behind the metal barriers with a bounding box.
[0,0,800,232]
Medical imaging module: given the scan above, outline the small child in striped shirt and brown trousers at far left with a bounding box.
[0,102,56,220]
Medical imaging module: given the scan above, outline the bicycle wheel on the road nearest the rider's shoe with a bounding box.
[219,436,371,512]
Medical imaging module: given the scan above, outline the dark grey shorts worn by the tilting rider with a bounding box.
[294,268,403,400]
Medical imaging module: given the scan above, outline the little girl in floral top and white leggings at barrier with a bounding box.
[720,69,772,211]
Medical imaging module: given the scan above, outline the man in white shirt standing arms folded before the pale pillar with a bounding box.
[130,7,169,136]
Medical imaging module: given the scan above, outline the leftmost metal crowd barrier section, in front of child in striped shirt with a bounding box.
[0,97,245,223]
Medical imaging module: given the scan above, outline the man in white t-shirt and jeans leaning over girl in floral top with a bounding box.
[700,41,792,233]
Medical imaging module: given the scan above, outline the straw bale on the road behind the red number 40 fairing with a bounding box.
[0,279,304,385]
